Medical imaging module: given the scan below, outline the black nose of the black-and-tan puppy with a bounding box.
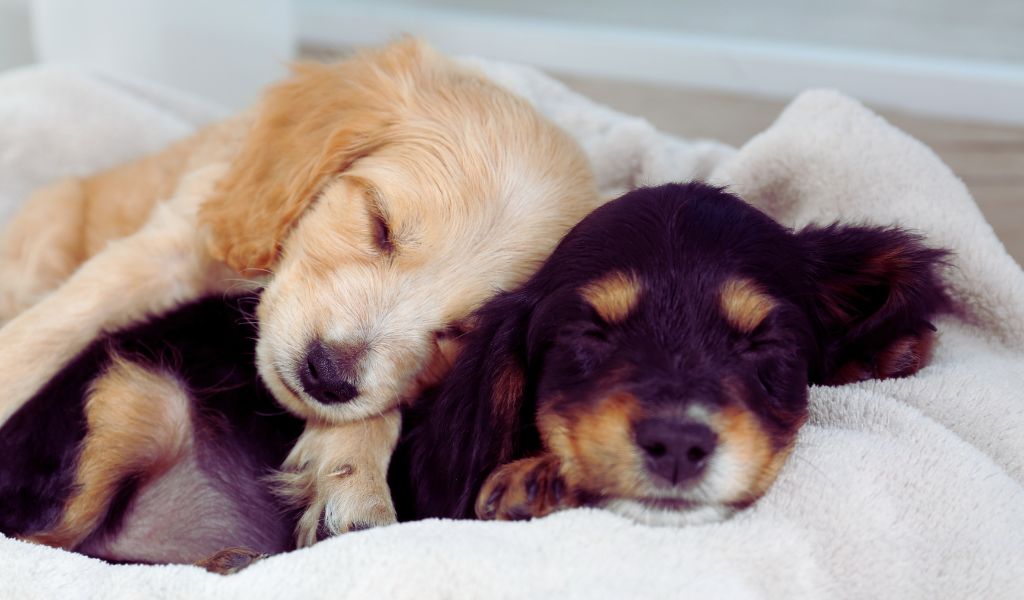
[636,419,718,485]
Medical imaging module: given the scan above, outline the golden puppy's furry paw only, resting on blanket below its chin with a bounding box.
[278,464,397,548]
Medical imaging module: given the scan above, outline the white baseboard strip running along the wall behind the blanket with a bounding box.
[296,0,1024,124]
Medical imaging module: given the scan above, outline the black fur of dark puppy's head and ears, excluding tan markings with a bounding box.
[391,183,948,519]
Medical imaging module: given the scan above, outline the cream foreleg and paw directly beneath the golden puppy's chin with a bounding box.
[275,410,401,546]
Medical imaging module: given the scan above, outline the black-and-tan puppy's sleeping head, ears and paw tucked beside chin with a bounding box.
[391,183,947,524]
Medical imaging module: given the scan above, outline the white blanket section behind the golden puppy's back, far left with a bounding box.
[0,66,223,222]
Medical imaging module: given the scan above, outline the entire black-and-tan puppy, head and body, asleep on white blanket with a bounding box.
[0,183,946,561]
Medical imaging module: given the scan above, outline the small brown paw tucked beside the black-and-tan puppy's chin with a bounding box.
[476,455,574,521]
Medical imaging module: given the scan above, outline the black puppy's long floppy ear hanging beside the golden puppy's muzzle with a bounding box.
[402,291,536,518]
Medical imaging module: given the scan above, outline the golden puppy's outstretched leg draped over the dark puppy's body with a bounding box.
[0,163,230,424]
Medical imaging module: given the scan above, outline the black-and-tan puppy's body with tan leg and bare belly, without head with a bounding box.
[0,295,302,570]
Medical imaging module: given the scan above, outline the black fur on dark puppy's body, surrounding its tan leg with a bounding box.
[0,295,301,535]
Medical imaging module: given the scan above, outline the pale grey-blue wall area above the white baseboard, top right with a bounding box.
[368,0,1024,66]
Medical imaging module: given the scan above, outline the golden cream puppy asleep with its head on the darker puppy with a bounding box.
[0,41,599,548]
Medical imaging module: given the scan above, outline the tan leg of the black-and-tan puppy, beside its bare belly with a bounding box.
[28,357,193,549]
